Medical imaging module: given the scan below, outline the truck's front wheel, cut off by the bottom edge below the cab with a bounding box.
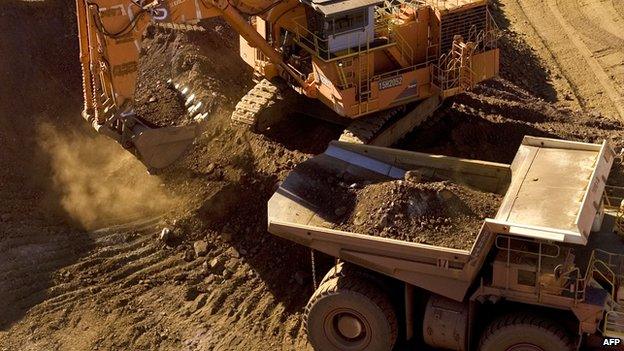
[479,313,575,351]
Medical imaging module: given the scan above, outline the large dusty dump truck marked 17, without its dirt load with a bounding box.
[268,136,624,351]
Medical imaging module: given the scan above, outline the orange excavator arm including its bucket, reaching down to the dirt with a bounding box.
[76,0,309,169]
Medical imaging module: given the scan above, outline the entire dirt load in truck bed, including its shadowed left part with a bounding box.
[297,163,502,250]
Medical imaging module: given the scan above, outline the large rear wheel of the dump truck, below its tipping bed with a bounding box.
[304,276,398,351]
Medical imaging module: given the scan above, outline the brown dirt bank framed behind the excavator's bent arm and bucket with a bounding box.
[135,18,251,127]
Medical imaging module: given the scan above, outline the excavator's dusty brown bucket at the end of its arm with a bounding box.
[132,124,199,170]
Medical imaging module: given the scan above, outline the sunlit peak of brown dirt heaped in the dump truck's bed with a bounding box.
[337,180,501,250]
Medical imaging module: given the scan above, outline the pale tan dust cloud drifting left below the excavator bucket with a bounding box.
[38,124,180,229]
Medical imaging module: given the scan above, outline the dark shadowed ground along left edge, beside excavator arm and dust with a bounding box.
[0,0,91,330]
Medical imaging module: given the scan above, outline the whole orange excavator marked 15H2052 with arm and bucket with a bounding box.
[76,0,499,170]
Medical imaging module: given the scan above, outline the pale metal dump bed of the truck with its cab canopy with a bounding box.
[268,137,613,300]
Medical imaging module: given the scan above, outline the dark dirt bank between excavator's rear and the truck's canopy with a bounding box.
[398,78,624,163]
